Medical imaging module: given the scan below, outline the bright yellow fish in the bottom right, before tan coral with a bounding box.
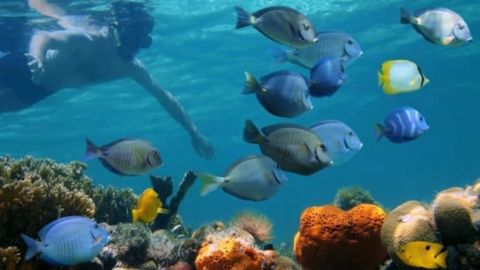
[397,241,447,269]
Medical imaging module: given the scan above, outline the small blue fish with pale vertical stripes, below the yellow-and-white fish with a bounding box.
[376,107,429,143]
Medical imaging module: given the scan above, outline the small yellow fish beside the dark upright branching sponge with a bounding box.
[132,188,168,223]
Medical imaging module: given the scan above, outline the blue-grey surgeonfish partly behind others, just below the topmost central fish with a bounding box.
[272,31,363,69]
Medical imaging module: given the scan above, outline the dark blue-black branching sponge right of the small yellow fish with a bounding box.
[150,171,197,230]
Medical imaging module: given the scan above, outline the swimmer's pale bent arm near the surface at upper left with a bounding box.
[29,30,93,64]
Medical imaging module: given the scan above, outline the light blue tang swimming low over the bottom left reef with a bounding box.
[21,216,110,266]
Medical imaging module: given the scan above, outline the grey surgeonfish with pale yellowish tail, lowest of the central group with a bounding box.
[196,155,287,201]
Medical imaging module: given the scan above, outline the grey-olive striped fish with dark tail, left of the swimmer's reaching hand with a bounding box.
[83,139,162,176]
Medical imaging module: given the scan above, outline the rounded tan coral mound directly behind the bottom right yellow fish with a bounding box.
[381,201,438,269]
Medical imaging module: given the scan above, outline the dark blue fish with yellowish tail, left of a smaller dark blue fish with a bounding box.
[243,70,313,117]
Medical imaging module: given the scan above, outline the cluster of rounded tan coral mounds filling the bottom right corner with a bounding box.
[382,181,480,270]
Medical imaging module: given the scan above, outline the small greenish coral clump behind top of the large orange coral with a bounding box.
[333,186,380,211]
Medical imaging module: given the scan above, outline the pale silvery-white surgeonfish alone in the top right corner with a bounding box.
[400,7,473,46]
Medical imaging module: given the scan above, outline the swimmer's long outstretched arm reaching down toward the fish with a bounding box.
[131,59,214,159]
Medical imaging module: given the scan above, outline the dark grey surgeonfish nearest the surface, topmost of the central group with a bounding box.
[235,6,317,48]
